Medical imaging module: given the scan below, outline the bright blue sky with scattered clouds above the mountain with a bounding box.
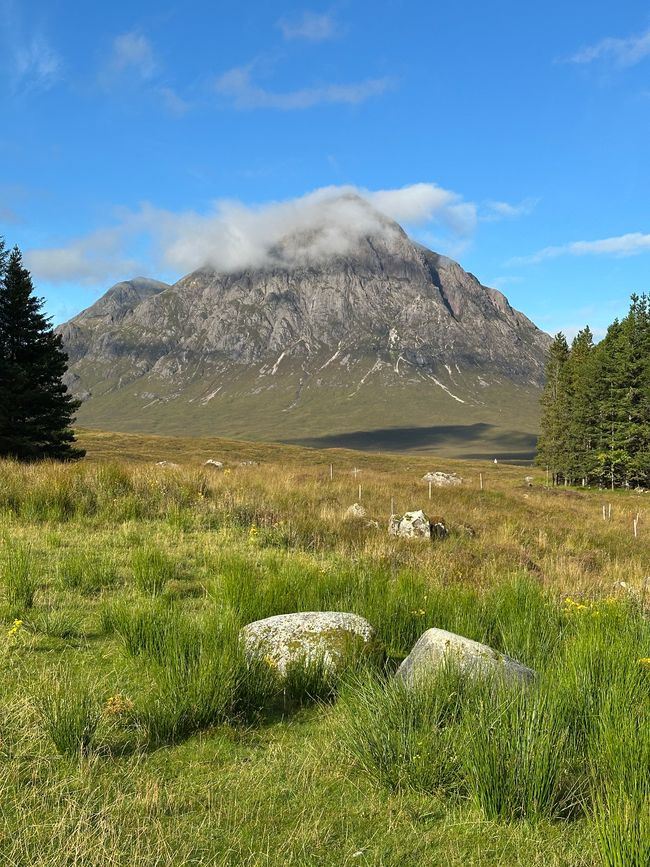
[0,0,650,334]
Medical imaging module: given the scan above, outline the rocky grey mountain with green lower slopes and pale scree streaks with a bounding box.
[58,197,550,457]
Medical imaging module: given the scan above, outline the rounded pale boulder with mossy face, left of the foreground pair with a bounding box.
[240,611,375,674]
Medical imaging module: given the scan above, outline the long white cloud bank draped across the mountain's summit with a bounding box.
[26,183,476,284]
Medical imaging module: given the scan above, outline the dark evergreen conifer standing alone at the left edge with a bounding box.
[0,242,85,461]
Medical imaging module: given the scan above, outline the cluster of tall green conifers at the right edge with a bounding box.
[537,294,650,488]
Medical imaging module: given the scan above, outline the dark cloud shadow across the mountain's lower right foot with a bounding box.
[284,422,537,461]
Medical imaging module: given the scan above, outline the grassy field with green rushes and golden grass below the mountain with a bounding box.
[0,431,650,867]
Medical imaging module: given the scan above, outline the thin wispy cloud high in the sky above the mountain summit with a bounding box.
[214,66,392,111]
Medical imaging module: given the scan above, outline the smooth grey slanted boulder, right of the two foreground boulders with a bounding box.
[396,629,535,684]
